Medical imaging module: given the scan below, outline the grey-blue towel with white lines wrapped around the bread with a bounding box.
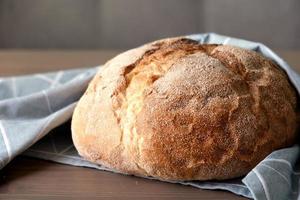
[0,33,300,200]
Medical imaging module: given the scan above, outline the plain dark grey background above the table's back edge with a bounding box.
[0,0,300,49]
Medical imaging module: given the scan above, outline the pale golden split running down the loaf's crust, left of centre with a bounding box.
[115,39,213,171]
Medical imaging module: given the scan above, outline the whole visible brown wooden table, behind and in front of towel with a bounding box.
[0,50,300,200]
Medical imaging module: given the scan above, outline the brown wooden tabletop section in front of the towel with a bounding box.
[0,157,246,199]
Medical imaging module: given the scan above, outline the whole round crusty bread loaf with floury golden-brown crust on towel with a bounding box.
[72,38,297,180]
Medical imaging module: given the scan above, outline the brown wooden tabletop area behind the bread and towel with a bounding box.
[0,50,300,77]
